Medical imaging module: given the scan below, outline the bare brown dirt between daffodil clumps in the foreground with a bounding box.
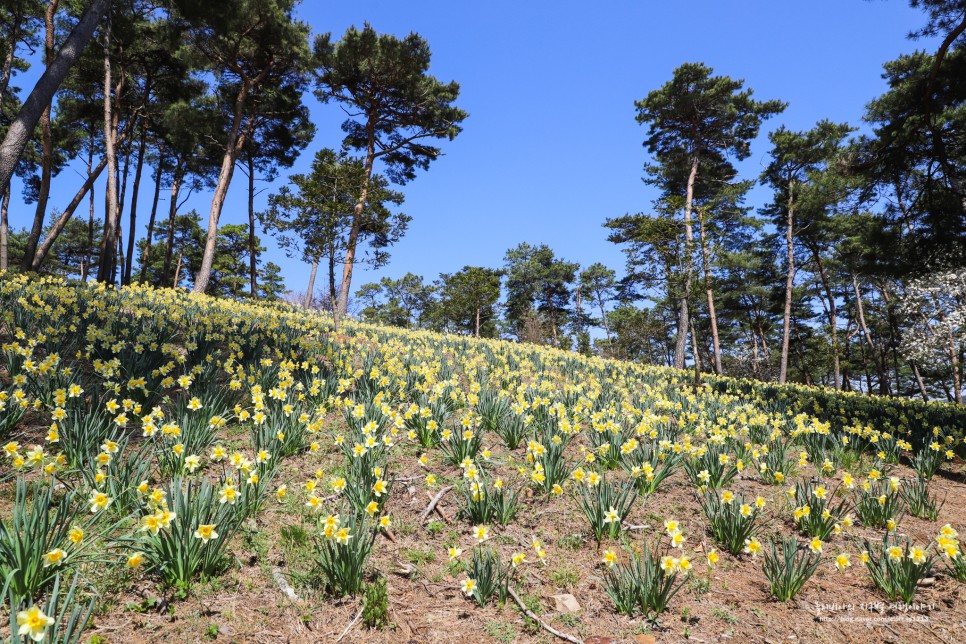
[47,418,966,644]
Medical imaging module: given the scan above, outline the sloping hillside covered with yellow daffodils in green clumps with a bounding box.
[0,275,966,644]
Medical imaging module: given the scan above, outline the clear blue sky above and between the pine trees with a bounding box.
[3,0,934,290]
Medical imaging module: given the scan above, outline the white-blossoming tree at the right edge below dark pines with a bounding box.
[900,269,966,403]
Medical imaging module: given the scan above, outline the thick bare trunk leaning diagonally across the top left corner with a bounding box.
[0,0,110,199]
